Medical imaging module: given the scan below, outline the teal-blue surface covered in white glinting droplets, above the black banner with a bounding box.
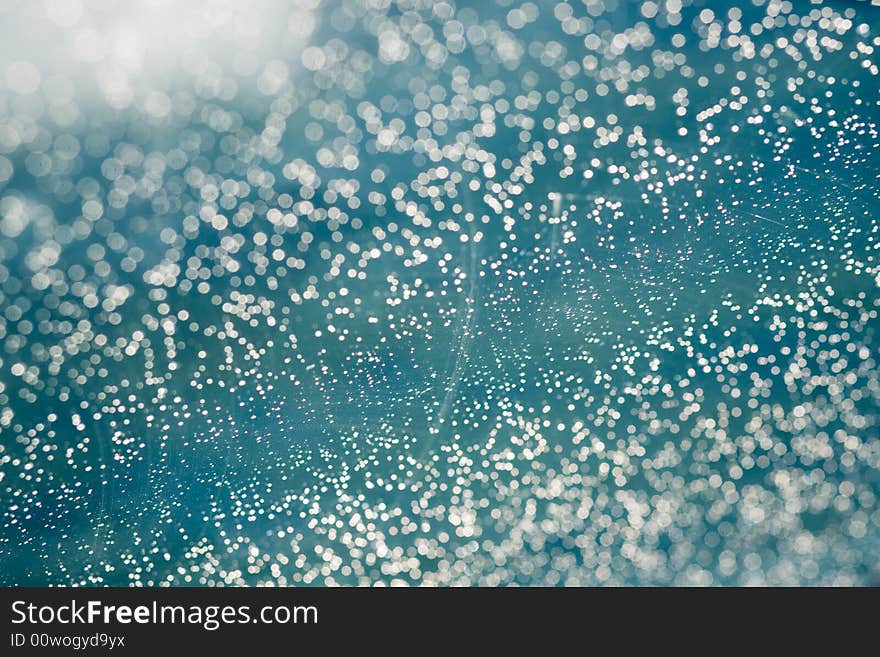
[0,0,880,586]
